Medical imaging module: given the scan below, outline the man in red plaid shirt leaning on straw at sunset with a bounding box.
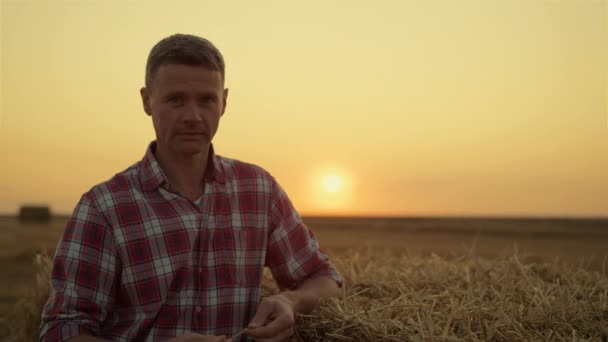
[40,34,342,342]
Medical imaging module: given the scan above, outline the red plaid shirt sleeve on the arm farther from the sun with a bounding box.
[40,193,120,341]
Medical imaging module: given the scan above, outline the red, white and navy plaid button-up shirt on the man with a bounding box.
[40,142,342,341]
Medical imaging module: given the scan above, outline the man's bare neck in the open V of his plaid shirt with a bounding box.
[155,145,209,201]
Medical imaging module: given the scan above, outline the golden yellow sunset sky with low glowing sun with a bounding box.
[0,0,608,216]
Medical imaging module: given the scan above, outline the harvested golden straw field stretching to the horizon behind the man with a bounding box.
[0,218,608,341]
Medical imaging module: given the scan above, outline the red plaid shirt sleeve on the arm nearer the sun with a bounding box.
[266,179,343,289]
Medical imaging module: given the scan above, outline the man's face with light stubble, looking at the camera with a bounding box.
[141,64,228,156]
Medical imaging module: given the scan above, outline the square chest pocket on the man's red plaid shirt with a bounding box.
[213,229,265,288]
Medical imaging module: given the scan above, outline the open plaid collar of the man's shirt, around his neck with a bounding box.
[139,141,225,191]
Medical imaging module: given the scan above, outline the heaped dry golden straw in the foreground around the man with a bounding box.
[4,250,608,341]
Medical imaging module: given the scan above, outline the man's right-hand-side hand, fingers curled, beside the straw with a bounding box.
[245,293,295,342]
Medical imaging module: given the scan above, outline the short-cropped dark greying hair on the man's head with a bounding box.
[146,33,225,88]
